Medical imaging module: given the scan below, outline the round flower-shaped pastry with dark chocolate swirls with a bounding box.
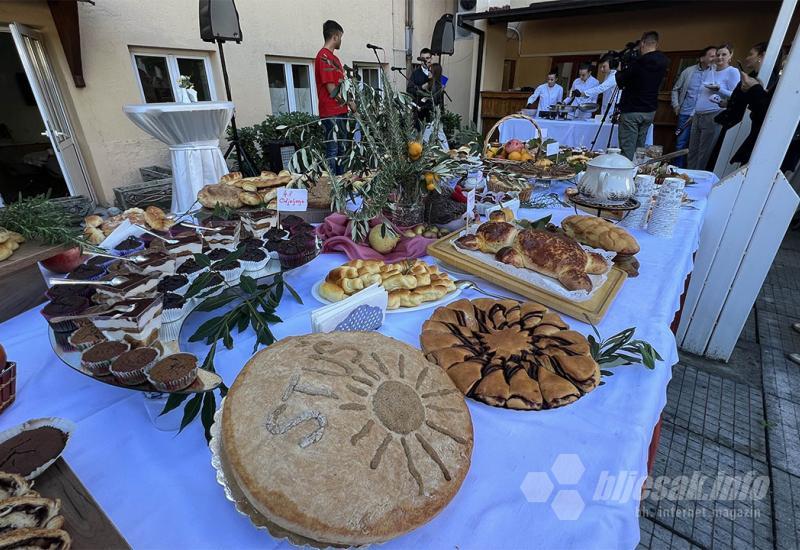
[420,299,600,410]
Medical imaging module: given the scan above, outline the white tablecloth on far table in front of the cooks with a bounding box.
[500,118,653,150]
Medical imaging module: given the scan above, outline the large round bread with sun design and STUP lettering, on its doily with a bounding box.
[209,332,473,548]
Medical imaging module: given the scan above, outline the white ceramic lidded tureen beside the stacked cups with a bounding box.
[578,148,636,204]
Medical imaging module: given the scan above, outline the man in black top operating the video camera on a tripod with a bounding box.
[615,31,669,160]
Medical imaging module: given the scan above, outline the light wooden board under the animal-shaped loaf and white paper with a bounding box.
[428,230,628,324]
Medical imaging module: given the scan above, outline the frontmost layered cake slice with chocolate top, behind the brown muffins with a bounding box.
[93,295,162,347]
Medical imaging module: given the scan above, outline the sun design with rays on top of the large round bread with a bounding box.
[303,341,471,495]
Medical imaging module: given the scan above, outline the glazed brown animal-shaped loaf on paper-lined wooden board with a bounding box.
[428,210,626,323]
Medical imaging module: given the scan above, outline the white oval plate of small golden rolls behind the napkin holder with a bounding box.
[311,260,461,313]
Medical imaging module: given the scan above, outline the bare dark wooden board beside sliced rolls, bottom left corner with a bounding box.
[33,458,130,550]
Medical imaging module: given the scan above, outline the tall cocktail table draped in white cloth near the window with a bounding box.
[123,101,233,213]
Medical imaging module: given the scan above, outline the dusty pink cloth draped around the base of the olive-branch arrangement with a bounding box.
[317,213,436,263]
